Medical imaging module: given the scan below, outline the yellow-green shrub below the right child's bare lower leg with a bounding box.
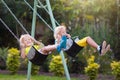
[85,56,100,80]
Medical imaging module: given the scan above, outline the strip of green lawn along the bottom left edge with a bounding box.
[0,74,78,80]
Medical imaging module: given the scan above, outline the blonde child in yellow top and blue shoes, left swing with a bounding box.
[20,34,66,58]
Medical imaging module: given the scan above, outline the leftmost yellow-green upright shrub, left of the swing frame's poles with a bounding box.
[7,48,20,74]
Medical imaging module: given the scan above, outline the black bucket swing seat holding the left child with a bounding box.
[27,46,48,66]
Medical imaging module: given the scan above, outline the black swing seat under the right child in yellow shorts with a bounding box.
[64,39,83,57]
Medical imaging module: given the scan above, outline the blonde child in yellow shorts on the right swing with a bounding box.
[54,26,110,57]
